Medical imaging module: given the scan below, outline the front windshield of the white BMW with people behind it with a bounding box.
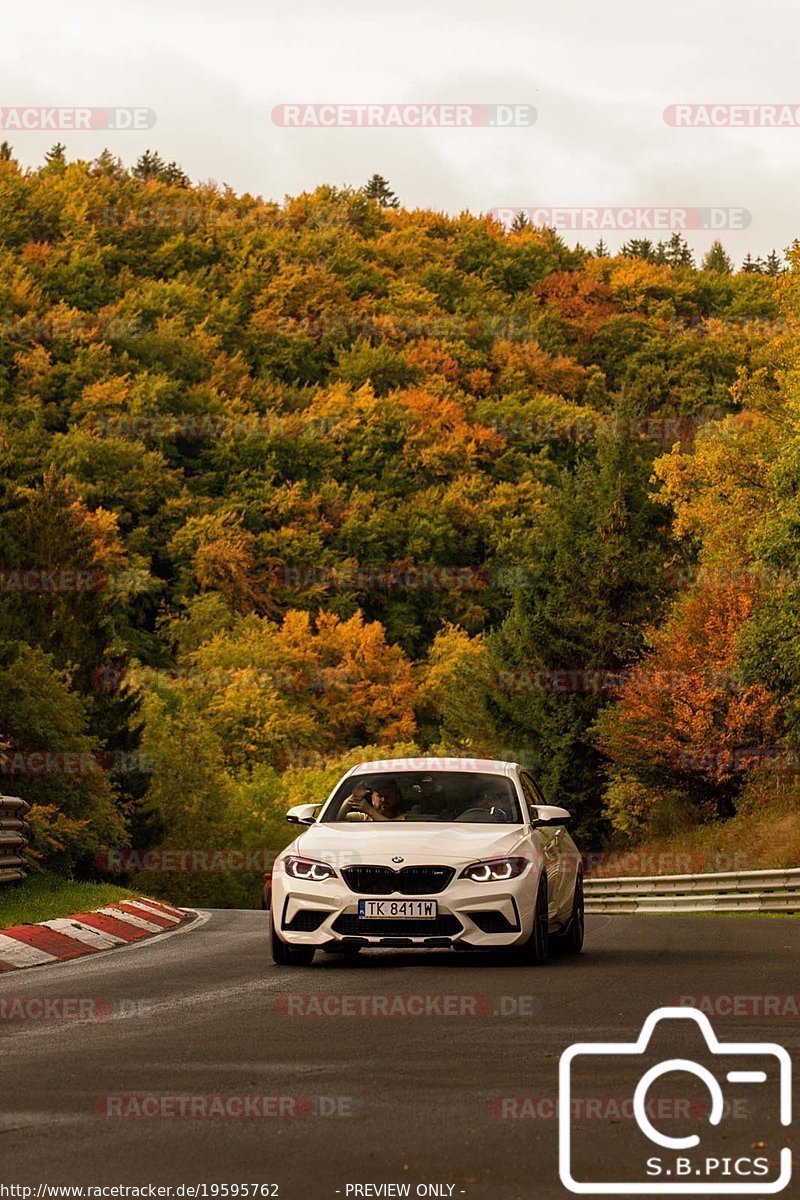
[321,770,522,824]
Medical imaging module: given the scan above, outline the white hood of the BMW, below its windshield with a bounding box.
[287,822,525,866]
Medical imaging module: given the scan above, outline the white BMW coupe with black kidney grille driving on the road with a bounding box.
[270,758,583,966]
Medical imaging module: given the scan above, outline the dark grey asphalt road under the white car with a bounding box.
[0,911,800,1200]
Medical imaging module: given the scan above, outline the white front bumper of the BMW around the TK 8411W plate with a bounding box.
[272,865,537,949]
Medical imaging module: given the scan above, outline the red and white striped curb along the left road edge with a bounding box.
[0,899,194,971]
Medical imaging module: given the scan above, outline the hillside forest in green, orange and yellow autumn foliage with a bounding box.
[0,145,800,904]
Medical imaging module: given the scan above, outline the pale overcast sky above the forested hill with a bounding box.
[6,0,800,259]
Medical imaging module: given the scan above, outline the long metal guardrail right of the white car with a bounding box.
[584,868,800,913]
